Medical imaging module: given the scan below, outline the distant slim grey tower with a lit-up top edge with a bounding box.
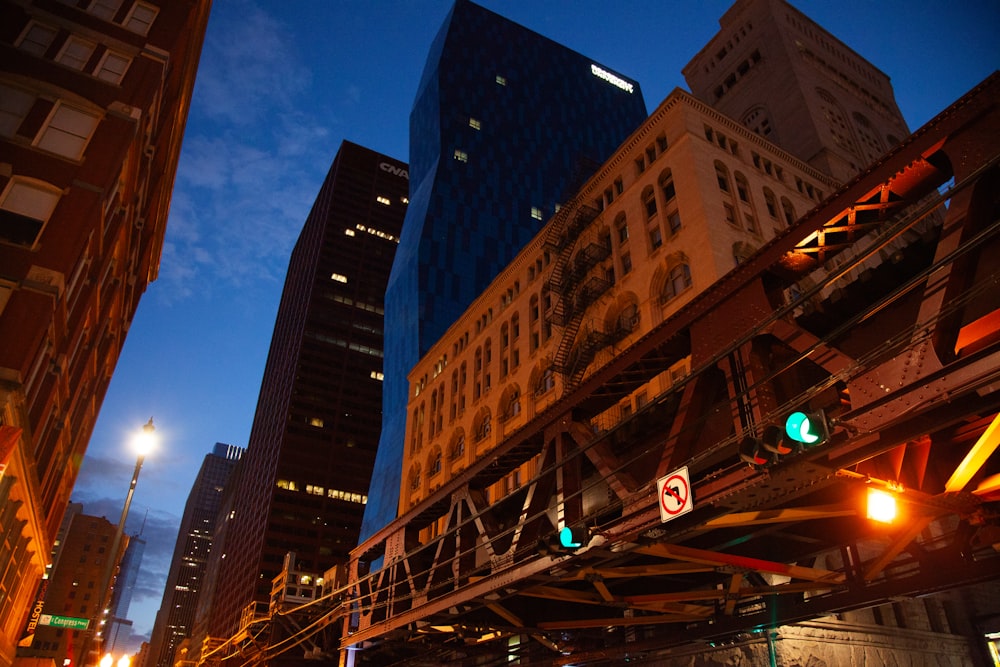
[149,442,244,667]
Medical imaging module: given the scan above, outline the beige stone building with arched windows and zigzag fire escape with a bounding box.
[400,90,835,530]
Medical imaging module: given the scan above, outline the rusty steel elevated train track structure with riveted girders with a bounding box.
[217,75,1000,665]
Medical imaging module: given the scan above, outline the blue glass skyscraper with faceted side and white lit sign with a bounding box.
[361,0,646,539]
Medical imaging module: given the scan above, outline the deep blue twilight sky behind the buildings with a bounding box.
[66,0,1000,656]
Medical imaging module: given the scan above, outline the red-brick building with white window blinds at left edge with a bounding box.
[0,0,211,667]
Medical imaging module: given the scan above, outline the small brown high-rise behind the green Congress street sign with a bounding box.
[18,513,123,665]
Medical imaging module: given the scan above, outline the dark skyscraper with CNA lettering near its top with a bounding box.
[207,141,409,638]
